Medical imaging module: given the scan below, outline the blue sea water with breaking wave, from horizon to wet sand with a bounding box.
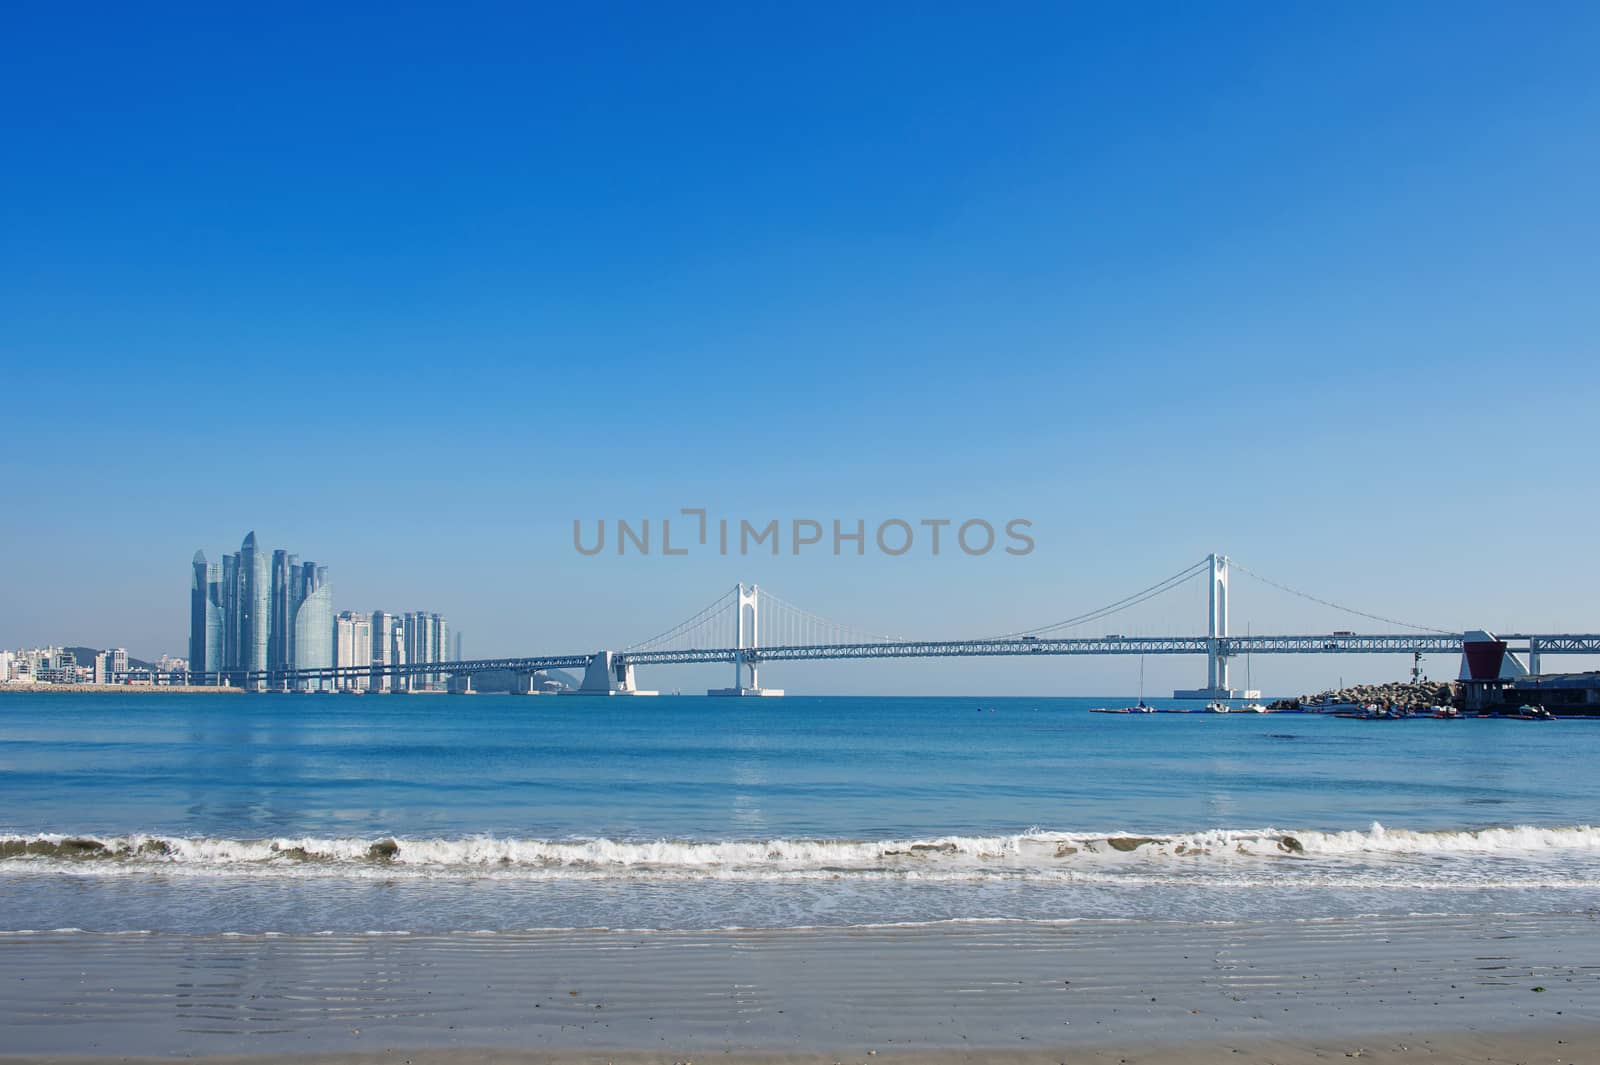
[0,694,1600,934]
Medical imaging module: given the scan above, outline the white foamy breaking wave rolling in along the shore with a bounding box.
[0,824,1600,883]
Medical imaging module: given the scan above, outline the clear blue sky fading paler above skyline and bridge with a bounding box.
[0,3,1600,694]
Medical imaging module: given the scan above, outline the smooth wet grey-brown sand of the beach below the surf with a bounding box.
[0,915,1600,1065]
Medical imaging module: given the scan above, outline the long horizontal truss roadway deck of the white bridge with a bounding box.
[202,633,1600,684]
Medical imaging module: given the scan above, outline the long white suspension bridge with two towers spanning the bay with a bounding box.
[209,555,1600,699]
